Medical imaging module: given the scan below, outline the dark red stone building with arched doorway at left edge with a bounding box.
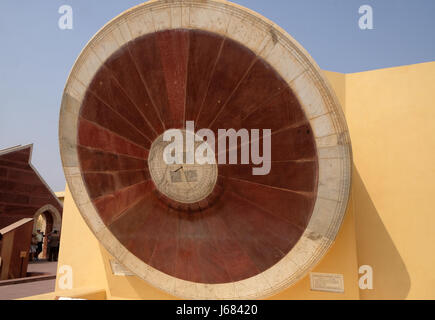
[0,145,63,275]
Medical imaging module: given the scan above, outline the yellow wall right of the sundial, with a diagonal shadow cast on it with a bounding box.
[346,62,435,299]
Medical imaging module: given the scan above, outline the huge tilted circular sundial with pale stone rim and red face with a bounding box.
[60,0,351,299]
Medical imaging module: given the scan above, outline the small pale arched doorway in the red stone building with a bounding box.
[32,205,62,259]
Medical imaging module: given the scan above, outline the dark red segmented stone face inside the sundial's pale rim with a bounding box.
[77,29,318,284]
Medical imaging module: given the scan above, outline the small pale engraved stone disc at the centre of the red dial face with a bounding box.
[148,130,218,203]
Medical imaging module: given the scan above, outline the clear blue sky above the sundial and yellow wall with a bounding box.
[0,0,435,191]
